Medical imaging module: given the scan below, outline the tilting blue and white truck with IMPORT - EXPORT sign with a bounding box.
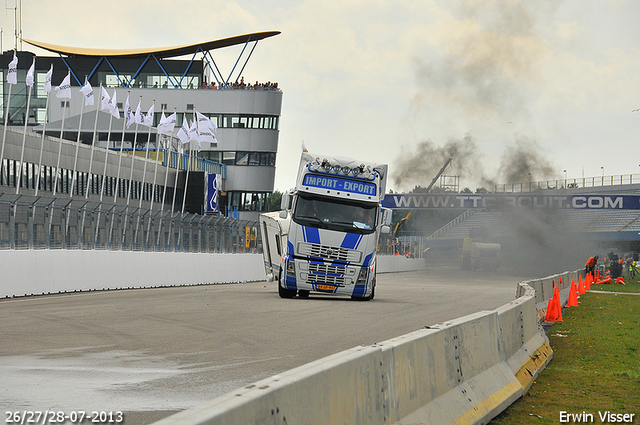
[260,151,391,301]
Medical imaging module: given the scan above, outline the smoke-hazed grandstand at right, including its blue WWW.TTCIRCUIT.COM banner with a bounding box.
[384,176,640,274]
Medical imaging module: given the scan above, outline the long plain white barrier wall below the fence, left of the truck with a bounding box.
[0,250,265,297]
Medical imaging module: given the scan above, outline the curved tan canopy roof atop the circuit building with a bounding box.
[22,31,280,58]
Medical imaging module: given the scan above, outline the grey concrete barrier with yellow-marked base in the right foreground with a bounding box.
[156,282,552,425]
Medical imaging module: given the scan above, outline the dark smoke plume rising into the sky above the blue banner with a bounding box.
[392,0,560,191]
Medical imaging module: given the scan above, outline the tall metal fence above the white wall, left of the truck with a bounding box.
[0,193,262,253]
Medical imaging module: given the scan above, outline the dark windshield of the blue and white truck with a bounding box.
[293,193,377,234]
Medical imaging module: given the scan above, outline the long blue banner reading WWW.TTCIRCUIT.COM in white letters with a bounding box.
[382,193,640,210]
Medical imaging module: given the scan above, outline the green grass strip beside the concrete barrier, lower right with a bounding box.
[491,281,640,425]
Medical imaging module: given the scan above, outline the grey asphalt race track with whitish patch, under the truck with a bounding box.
[0,267,526,424]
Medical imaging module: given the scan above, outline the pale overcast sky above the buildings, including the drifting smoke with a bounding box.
[1,0,640,191]
